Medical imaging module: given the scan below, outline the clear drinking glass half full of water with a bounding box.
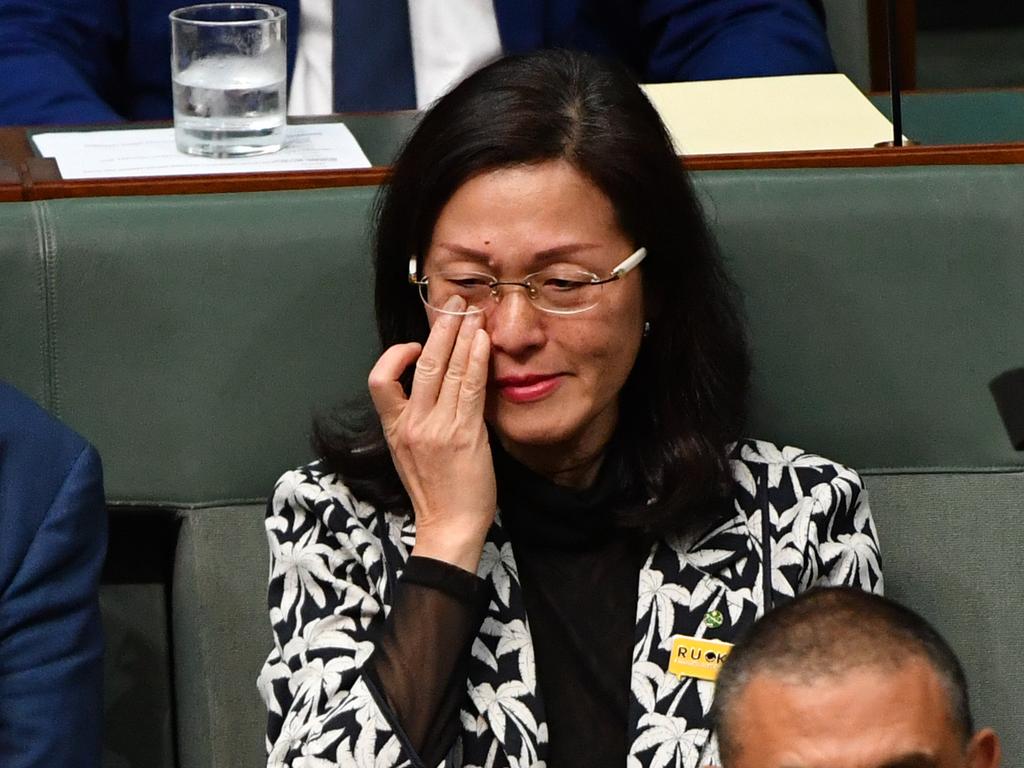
[170,3,287,158]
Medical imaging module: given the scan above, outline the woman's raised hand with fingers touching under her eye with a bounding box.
[370,297,498,572]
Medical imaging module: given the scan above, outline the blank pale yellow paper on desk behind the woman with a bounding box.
[643,75,893,155]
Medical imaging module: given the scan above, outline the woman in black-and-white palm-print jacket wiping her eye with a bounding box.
[259,51,882,768]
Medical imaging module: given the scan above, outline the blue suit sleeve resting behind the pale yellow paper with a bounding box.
[639,0,836,82]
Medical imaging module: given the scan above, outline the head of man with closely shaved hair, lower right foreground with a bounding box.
[714,588,999,768]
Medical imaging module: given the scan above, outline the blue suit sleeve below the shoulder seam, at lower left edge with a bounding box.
[0,446,106,768]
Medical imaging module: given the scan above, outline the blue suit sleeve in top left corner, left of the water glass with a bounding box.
[0,0,125,125]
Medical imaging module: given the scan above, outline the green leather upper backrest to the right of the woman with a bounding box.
[712,166,1024,468]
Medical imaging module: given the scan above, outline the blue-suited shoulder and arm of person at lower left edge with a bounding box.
[0,382,106,768]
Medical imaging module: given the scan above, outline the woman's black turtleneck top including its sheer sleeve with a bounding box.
[369,446,649,768]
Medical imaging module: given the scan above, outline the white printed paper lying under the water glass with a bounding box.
[32,123,370,179]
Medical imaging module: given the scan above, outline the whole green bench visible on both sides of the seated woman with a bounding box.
[0,166,1024,768]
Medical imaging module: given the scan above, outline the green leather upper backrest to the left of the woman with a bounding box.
[0,188,376,506]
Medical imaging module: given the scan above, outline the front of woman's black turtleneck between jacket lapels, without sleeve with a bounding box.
[496,444,649,768]
